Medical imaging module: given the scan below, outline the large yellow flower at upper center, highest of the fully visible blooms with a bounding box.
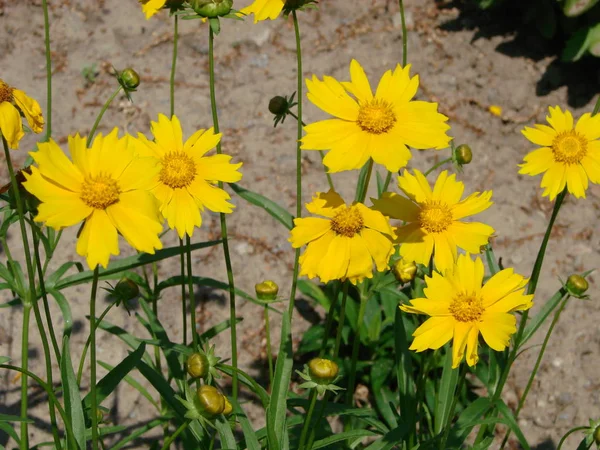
[302,60,450,172]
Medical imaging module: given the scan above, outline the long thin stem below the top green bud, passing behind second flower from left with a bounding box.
[208,27,238,401]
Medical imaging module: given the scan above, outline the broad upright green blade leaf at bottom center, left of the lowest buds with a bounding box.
[267,311,293,449]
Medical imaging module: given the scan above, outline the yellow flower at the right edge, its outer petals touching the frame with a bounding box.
[519,106,600,200]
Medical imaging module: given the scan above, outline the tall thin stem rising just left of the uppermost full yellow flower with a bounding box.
[288,10,304,320]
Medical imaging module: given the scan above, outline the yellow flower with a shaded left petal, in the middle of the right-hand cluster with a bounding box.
[373,170,494,272]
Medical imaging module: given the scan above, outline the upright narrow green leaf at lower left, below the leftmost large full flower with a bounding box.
[60,336,86,450]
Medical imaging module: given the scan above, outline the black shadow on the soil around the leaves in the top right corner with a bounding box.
[435,0,600,108]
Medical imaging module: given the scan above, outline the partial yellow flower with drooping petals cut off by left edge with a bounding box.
[0,79,44,149]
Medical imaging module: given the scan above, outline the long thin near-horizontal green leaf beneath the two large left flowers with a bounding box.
[55,241,222,290]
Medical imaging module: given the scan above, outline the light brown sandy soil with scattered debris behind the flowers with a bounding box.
[0,0,600,449]
